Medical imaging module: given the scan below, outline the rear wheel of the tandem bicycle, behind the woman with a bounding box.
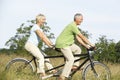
[5,58,34,80]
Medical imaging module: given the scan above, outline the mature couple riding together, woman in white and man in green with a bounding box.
[25,13,95,80]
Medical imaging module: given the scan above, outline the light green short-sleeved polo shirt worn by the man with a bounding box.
[56,22,80,48]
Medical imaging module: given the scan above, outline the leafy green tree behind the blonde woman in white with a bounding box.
[5,20,54,53]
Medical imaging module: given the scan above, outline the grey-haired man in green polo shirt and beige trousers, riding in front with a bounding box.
[56,13,94,80]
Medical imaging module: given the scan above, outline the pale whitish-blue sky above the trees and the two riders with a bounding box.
[0,0,120,48]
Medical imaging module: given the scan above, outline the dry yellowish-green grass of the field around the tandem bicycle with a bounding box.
[0,53,120,80]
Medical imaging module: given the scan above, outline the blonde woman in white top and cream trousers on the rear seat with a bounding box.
[25,14,53,76]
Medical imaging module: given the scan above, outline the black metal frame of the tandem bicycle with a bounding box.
[28,51,96,77]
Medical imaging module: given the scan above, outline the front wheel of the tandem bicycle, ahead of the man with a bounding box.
[82,61,111,80]
